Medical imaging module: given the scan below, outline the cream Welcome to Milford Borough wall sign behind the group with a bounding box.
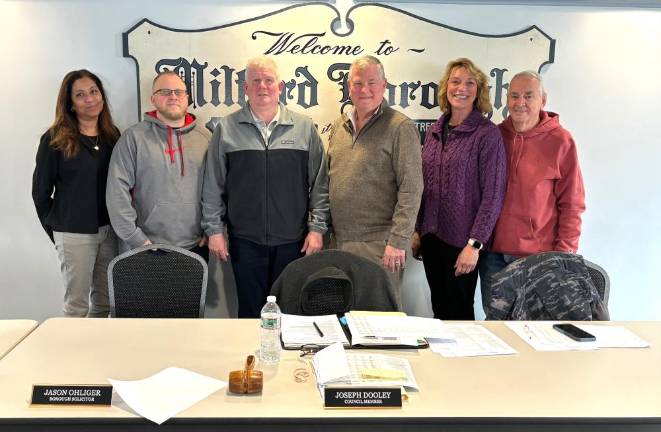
[123,3,555,137]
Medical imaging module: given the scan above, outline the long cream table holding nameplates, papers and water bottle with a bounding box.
[0,318,661,431]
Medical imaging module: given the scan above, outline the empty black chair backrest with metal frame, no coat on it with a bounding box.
[108,244,208,318]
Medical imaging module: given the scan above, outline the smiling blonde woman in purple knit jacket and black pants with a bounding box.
[412,58,506,320]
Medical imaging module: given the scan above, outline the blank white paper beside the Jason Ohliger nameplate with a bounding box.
[108,367,227,425]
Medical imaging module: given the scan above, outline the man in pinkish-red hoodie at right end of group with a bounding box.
[480,71,585,312]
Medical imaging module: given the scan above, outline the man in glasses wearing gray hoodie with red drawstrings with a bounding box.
[106,71,211,261]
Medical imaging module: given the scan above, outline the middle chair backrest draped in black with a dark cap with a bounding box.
[271,249,397,315]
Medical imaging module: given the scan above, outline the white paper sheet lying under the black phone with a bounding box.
[505,321,599,351]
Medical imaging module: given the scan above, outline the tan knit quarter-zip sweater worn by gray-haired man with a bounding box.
[328,102,422,249]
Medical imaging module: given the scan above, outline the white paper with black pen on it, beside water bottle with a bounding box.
[282,314,349,348]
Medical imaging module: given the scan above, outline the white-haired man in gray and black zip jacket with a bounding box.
[202,57,329,318]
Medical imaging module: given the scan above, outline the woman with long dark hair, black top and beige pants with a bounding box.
[32,69,119,317]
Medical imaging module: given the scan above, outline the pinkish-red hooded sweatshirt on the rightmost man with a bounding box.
[492,111,585,257]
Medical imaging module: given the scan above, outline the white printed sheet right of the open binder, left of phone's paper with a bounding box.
[427,324,517,357]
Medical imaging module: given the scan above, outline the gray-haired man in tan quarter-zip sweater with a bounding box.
[328,56,422,306]
